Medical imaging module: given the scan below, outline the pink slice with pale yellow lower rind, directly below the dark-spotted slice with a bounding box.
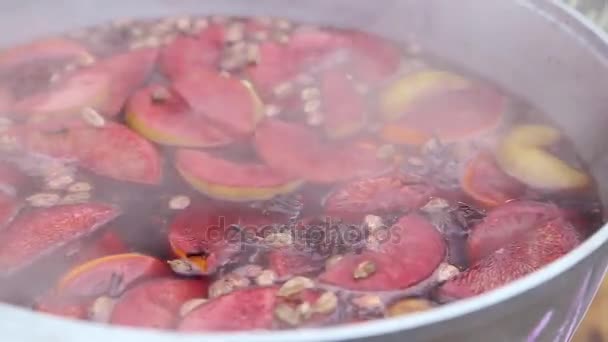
[175,150,302,202]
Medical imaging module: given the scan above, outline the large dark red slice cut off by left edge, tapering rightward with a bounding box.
[0,203,120,276]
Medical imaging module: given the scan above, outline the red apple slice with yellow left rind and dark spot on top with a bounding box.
[126,86,233,147]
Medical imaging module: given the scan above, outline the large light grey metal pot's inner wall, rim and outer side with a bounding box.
[0,0,608,342]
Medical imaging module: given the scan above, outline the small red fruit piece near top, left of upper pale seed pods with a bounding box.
[160,24,224,79]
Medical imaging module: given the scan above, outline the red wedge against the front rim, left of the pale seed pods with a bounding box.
[177,287,277,332]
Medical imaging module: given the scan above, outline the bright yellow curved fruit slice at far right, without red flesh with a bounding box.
[497,125,591,191]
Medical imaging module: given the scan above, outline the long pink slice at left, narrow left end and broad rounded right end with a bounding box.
[12,122,162,184]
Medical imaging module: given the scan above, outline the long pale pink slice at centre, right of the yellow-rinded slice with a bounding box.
[254,120,390,183]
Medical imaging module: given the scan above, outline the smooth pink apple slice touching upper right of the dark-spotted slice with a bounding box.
[173,69,264,135]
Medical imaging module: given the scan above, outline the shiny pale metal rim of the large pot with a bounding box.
[0,0,608,342]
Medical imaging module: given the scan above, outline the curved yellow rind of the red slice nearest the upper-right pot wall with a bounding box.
[379,70,470,121]
